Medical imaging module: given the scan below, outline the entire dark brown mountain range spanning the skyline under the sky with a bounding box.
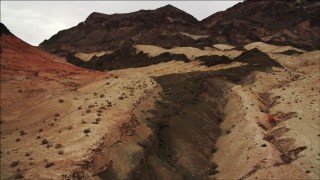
[40,0,320,70]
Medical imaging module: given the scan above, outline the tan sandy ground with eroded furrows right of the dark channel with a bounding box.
[213,43,320,179]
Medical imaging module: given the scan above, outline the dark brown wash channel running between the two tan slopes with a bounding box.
[100,50,280,179]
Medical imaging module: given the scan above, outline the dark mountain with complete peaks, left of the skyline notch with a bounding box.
[40,5,211,52]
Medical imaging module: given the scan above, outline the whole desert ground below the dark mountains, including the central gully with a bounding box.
[1,34,320,179]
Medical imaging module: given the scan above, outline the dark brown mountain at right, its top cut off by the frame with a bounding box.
[202,0,320,49]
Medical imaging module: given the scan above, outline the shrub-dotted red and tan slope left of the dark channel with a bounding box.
[1,23,155,179]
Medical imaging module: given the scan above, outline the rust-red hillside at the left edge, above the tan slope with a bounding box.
[1,24,102,116]
